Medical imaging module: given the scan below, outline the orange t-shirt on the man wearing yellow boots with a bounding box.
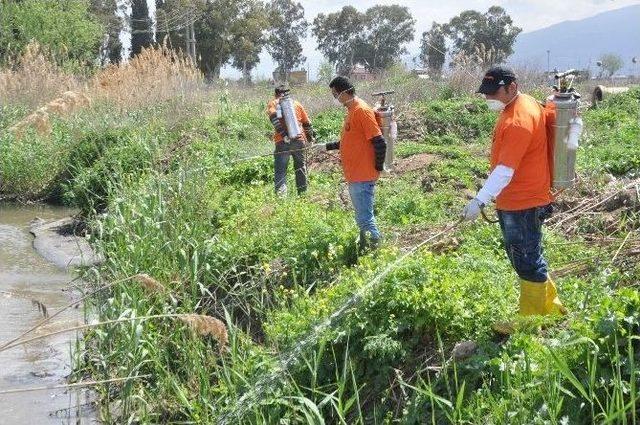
[491,94,553,211]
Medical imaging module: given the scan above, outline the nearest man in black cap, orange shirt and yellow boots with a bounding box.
[462,67,566,316]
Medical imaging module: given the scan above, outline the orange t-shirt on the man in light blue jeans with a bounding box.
[340,98,382,183]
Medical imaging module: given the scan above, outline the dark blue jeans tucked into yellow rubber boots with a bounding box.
[498,205,552,282]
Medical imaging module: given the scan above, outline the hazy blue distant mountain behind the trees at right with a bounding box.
[509,5,640,74]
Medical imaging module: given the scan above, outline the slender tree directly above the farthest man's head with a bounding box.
[267,0,309,79]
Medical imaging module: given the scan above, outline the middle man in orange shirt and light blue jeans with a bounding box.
[318,77,387,248]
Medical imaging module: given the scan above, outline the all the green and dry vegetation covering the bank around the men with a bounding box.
[0,44,640,424]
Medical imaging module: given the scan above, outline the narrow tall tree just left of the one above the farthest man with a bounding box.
[231,0,269,83]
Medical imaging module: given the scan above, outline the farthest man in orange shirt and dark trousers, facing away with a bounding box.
[267,85,314,195]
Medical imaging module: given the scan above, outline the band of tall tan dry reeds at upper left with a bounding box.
[0,43,211,132]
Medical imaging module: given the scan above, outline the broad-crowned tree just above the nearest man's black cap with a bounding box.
[444,6,522,66]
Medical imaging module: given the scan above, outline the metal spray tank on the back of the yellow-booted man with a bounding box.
[547,69,582,189]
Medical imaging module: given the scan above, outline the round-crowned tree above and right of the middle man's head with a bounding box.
[356,4,416,71]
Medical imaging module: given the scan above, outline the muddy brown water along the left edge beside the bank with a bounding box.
[0,204,89,424]
